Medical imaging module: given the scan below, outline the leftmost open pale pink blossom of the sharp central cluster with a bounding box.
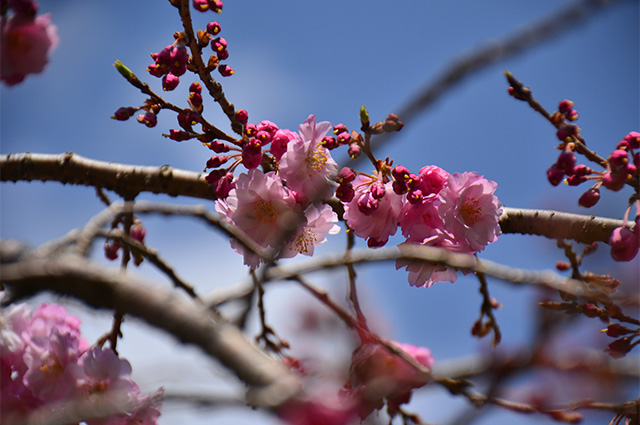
[216,169,304,268]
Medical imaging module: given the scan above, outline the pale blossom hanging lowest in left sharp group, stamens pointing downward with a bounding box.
[280,204,340,258]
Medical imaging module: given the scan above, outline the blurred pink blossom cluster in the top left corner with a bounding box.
[0,0,58,86]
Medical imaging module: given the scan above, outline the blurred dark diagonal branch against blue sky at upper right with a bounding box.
[362,0,624,157]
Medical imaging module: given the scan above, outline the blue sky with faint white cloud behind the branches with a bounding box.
[0,0,640,424]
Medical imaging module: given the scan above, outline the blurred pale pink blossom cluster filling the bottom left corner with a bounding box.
[0,304,163,425]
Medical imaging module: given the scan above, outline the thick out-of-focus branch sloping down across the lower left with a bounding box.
[0,241,299,406]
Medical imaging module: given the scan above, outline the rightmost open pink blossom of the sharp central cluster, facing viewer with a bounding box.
[438,172,502,252]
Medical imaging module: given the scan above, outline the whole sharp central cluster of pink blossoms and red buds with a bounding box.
[207,115,502,287]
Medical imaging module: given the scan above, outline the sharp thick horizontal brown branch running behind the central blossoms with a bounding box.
[0,152,622,243]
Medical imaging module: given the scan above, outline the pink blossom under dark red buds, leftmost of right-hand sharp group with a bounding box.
[344,175,403,247]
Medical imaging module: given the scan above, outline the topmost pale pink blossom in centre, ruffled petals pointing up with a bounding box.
[279,115,338,201]
